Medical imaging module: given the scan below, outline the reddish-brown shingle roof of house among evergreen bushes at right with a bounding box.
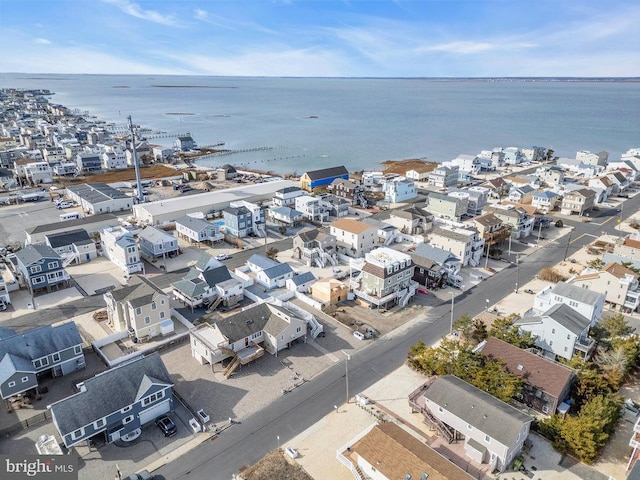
[482,337,573,398]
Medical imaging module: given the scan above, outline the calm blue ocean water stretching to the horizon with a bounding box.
[0,74,640,173]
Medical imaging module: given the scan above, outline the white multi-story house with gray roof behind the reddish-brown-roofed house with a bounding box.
[514,303,595,360]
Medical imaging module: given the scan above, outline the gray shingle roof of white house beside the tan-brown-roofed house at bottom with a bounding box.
[424,375,533,445]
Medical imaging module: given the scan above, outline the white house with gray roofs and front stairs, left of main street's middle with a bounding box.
[189,303,307,376]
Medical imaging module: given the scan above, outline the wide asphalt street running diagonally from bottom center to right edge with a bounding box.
[155,195,640,480]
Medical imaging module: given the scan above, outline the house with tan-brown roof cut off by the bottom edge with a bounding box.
[337,422,474,480]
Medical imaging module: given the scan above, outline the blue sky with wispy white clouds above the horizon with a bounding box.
[0,0,640,77]
